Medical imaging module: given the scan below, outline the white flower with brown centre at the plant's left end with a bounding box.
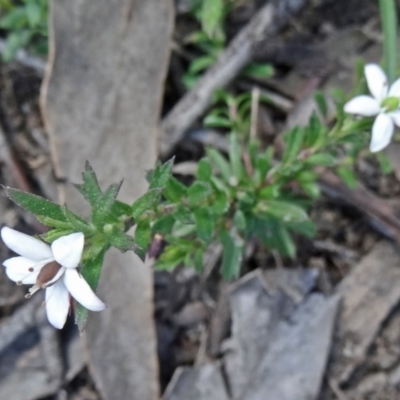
[1,227,105,329]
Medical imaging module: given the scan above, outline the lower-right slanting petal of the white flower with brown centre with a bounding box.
[64,269,106,311]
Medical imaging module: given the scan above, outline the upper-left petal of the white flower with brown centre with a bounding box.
[1,227,53,261]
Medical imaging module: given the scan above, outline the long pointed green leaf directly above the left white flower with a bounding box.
[5,187,69,228]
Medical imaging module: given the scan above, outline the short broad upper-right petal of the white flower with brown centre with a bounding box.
[51,232,85,268]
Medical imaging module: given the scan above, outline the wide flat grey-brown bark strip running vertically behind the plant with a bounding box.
[42,0,173,400]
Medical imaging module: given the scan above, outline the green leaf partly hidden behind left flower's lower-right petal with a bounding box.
[75,245,108,332]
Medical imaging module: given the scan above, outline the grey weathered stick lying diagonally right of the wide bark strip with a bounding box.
[160,0,307,156]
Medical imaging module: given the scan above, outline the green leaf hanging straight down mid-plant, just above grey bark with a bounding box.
[220,229,244,280]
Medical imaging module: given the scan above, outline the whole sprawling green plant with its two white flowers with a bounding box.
[1,0,400,329]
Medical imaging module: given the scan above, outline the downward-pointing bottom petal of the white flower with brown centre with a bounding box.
[46,279,70,329]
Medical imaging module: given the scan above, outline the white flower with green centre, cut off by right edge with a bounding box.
[344,64,400,152]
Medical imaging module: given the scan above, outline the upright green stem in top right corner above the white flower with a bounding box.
[379,0,397,83]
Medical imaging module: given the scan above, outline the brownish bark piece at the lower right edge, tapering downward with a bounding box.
[329,241,400,384]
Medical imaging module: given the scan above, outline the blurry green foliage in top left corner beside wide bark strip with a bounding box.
[0,0,48,61]
